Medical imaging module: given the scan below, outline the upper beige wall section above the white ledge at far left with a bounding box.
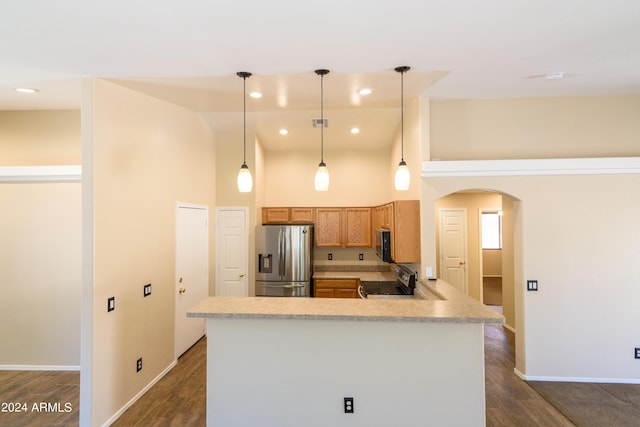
[0,110,80,166]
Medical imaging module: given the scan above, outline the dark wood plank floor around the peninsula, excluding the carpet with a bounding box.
[0,310,573,427]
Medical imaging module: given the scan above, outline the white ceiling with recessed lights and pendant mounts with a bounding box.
[0,0,640,149]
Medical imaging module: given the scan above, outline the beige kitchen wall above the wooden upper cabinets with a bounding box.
[259,98,428,206]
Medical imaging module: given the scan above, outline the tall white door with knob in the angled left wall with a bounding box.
[175,204,209,359]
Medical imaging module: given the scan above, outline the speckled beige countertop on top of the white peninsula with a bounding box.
[187,278,504,323]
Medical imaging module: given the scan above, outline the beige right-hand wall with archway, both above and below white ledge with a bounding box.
[422,95,640,382]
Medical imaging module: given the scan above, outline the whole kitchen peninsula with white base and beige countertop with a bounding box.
[187,281,503,426]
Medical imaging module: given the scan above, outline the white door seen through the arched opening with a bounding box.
[440,209,468,294]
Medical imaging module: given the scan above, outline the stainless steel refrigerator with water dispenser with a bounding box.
[256,225,313,297]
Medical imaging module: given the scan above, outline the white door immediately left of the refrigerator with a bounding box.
[216,208,249,297]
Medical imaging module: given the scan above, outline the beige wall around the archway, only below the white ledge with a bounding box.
[423,175,640,381]
